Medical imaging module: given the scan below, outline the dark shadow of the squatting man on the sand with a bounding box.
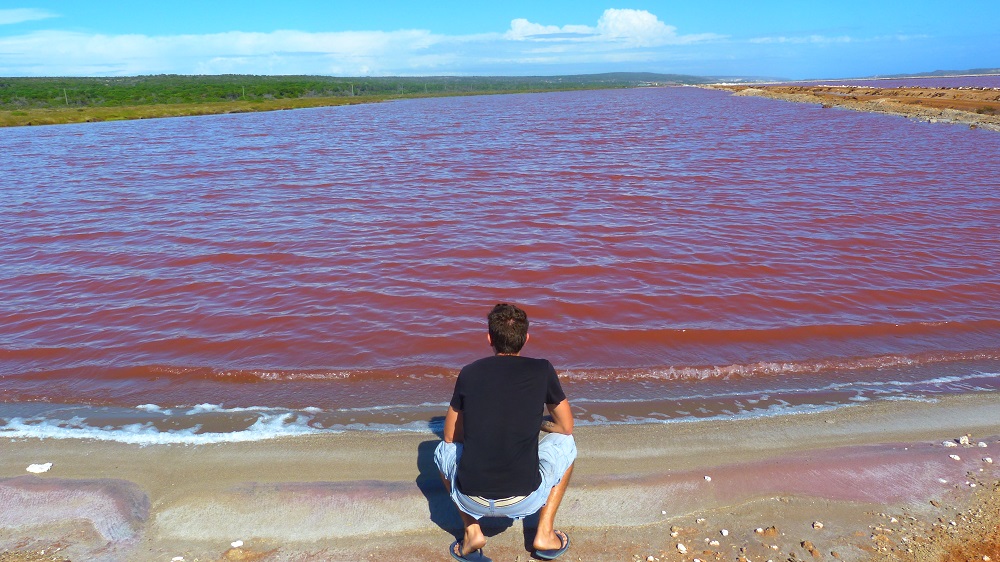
[416,416,516,545]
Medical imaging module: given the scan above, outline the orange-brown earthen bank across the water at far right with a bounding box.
[708,85,1000,131]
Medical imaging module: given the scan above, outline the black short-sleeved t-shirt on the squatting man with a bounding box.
[451,355,566,499]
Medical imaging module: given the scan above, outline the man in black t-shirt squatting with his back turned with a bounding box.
[434,303,576,561]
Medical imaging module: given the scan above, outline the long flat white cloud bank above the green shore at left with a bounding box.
[0,31,440,76]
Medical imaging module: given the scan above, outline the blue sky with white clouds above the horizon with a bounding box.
[0,0,1000,79]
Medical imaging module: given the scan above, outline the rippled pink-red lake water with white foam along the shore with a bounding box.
[0,88,1000,435]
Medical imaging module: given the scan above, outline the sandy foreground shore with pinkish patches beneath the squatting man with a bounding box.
[0,394,1000,562]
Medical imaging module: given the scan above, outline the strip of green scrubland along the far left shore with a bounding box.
[0,73,708,127]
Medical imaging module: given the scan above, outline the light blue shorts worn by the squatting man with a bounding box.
[434,433,576,519]
